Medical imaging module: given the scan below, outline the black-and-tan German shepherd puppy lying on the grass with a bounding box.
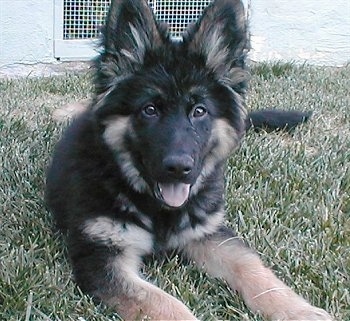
[46,0,331,320]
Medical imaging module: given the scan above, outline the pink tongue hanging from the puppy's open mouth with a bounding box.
[159,183,190,207]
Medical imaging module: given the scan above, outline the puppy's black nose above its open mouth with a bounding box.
[163,154,194,179]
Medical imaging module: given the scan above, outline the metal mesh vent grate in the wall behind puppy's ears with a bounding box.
[63,0,211,40]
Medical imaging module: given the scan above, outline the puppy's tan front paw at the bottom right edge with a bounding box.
[272,305,333,321]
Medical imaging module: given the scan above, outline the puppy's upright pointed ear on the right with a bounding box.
[184,0,249,80]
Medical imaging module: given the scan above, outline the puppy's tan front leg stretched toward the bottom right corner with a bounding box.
[185,228,332,321]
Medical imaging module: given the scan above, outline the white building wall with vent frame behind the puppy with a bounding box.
[0,0,350,68]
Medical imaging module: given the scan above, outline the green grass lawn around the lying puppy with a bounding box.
[0,63,350,321]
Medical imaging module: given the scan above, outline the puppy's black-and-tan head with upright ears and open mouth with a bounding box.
[94,0,247,208]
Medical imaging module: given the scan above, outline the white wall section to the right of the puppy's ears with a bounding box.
[250,0,350,65]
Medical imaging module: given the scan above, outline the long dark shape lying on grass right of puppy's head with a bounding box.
[246,109,312,132]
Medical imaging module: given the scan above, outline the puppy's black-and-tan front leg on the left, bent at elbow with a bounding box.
[73,216,196,321]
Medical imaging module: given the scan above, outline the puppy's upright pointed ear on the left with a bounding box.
[96,0,167,93]
